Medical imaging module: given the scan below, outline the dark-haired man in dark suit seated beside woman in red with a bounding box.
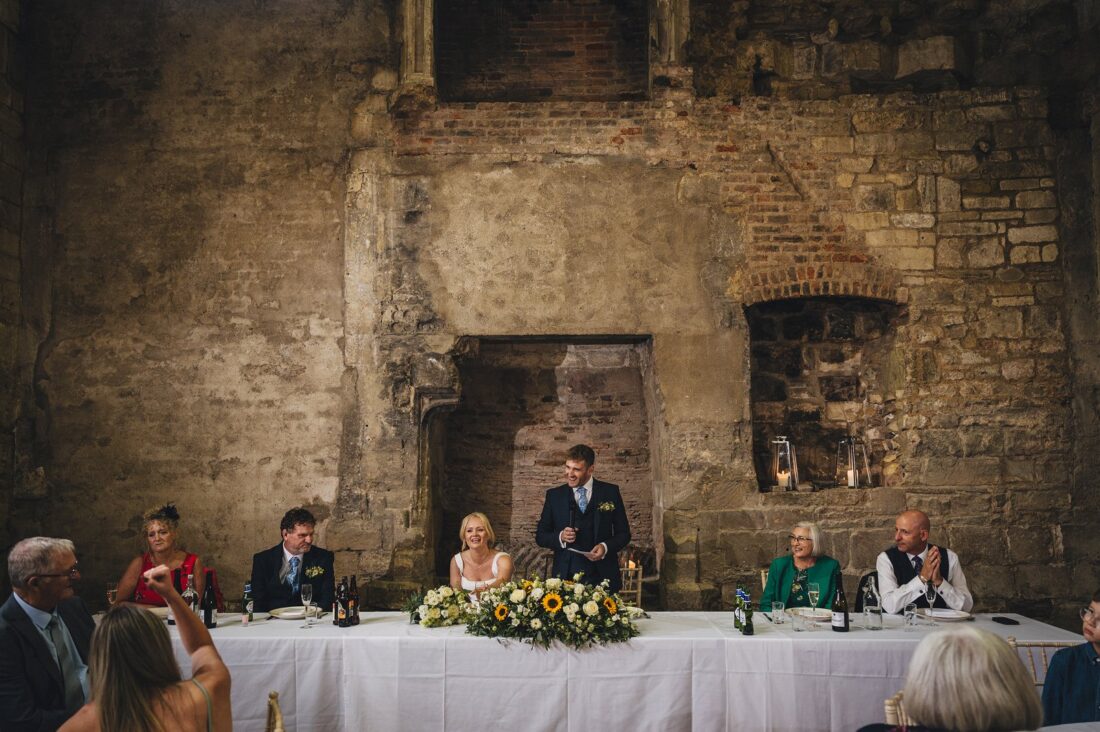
[252,509,336,612]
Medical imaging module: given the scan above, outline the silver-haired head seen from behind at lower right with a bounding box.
[904,626,1043,732]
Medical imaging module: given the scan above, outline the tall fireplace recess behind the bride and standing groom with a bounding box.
[429,338,656,578]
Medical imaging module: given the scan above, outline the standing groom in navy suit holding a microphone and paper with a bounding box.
[535,445,630,592]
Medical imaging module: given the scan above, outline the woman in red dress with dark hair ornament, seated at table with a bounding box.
[117,503,206,607]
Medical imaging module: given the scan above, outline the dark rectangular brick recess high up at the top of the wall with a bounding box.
[435,0,649,101]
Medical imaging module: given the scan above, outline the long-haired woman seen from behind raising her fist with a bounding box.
[61,565,233,732]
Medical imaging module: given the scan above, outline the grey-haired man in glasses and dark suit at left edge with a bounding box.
[0,536,96,732]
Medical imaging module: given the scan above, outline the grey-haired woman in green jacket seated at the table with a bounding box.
[760,522,840,612]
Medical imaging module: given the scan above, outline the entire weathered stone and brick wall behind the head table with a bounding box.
[0,0,1100,623]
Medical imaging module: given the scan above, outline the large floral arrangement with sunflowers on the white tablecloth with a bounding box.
[466,575,642,648]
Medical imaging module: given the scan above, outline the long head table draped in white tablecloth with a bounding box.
[172,612,1080,732]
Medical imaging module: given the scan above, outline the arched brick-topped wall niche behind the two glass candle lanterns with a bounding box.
[745,297,905,492]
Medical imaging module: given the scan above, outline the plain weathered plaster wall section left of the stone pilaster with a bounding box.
[10,2,394,602]
